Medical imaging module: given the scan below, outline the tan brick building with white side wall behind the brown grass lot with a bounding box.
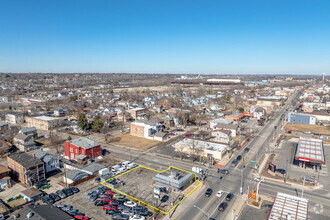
[130,121,162,139]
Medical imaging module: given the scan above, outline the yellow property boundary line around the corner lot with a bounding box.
[101,165,202,214]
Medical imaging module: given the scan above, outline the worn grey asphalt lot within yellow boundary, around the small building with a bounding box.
[105,167,188,212]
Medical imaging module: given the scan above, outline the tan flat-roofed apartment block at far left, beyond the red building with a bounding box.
[25,116,62,130]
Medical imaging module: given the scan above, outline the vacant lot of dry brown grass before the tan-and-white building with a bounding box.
[111,134,160,151]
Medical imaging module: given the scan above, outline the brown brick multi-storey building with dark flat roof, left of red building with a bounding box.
[7,153,46,185]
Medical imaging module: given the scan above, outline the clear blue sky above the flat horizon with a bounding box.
[0,0,330,74]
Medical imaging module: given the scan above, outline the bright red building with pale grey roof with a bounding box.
[64,137,101,160]
